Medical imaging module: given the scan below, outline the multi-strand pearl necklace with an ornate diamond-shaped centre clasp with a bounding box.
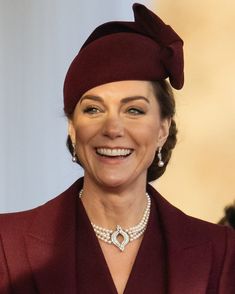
[79,189,151,251]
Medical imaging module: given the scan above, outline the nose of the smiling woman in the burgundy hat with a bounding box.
[103,115,124,139]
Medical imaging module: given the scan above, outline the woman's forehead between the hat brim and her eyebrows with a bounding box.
[82,81,154,99]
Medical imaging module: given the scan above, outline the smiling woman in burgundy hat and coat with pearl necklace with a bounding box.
[0,4,235,294]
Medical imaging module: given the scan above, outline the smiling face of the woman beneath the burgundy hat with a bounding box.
[69,81,170,187]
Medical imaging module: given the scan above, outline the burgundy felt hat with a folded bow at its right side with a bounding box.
[64,3,184,114]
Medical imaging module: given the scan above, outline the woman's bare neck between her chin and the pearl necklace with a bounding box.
[81,179,147,229]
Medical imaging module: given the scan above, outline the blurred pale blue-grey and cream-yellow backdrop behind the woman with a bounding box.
[0,0,235,222]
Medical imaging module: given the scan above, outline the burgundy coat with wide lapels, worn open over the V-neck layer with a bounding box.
[0,180,235,294]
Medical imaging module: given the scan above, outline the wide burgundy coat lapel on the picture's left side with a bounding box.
[25,184,78,294]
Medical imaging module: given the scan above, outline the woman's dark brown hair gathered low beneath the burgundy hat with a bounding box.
[66,80,177,182]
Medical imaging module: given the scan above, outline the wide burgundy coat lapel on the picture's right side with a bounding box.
[149,187,212,294]
